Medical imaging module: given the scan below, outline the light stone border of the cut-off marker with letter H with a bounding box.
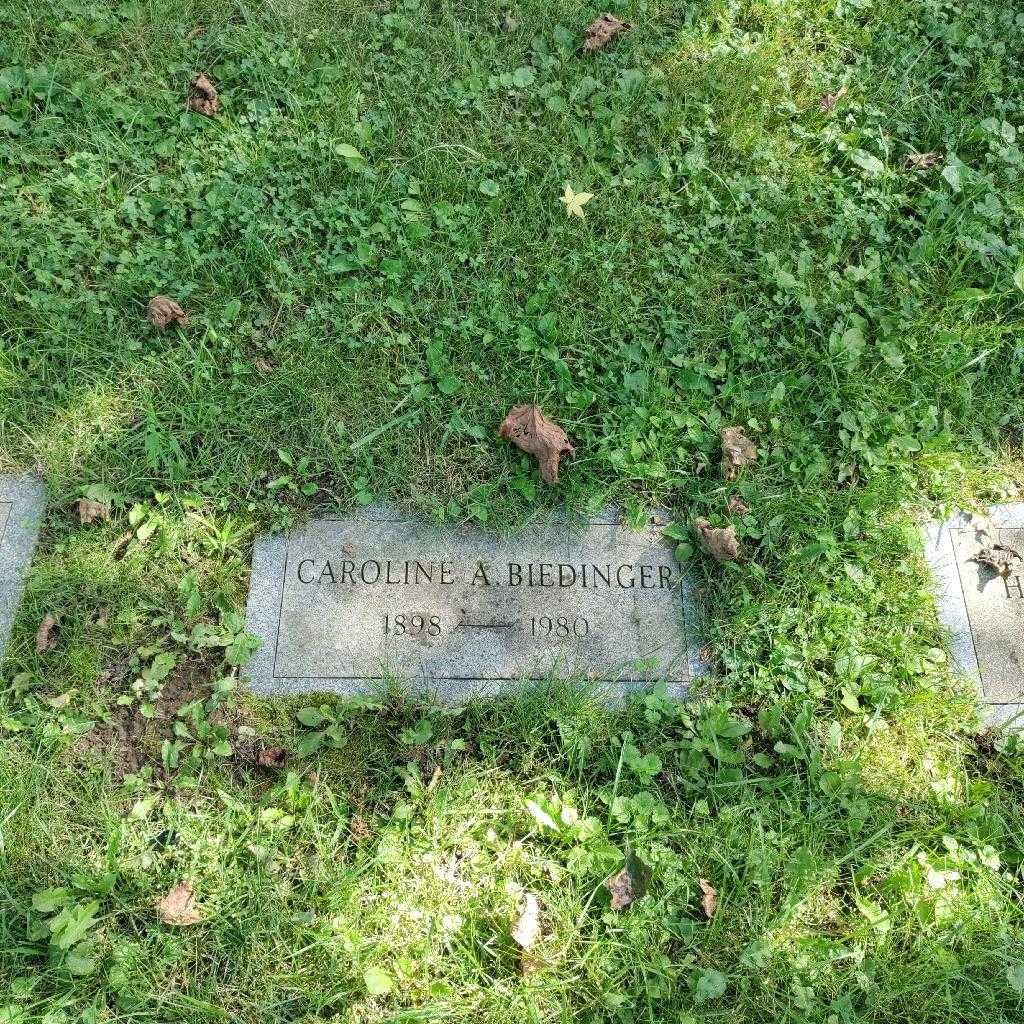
[922,502,1024,729]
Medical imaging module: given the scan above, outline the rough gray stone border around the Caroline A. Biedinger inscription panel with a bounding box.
[244,506,709,700]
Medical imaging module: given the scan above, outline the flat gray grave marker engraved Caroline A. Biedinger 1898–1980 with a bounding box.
[248,509,700,698]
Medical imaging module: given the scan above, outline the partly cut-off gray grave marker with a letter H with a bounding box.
[925,504,1024,725]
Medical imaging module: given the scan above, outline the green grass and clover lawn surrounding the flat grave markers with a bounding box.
[0,0,1024,1024]
